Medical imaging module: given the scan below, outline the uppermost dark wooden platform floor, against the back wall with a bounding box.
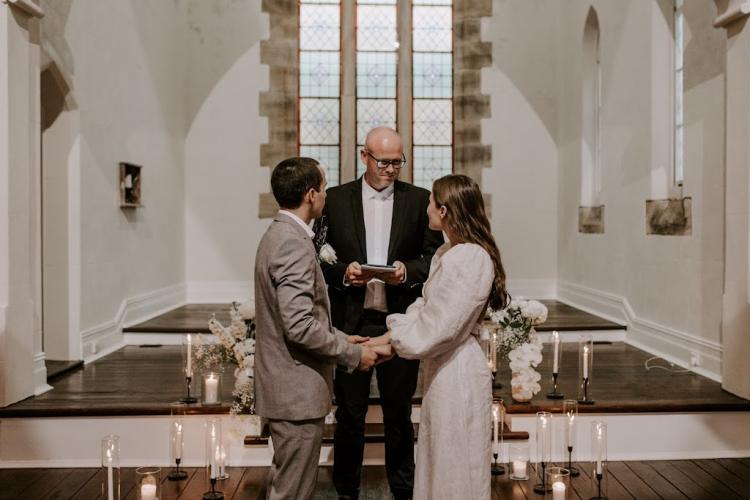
[124,300,625,333]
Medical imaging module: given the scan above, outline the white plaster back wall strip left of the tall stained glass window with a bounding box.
[182,0,269,301]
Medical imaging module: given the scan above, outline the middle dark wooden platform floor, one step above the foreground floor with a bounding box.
[0,342,750,418]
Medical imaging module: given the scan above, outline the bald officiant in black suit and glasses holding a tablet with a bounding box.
[317,127,443,500]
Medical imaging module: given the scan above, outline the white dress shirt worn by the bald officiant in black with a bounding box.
[362,177,394,312]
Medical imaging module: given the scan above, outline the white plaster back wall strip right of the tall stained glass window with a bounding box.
[482,0,563,296]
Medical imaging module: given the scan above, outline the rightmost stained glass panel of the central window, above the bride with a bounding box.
[412,0,453,189]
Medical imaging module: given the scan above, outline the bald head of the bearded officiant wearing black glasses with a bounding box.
[360,127,404,191]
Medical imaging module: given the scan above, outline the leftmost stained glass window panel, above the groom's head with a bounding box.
[299,0,341,186]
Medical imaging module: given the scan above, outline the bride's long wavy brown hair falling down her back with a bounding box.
[432,175,510,310]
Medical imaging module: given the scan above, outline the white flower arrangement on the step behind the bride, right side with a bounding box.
[488,298,547,401]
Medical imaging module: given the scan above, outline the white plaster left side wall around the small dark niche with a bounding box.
[45,0,187,356]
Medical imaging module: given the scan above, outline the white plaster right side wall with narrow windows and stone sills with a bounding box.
[557,0,724,364]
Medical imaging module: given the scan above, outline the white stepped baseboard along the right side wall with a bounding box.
[557,281,722,382]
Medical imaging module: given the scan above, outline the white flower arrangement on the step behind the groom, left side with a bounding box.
[204,302,255,415]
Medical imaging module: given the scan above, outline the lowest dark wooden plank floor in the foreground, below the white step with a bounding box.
[0,458,750,500]
